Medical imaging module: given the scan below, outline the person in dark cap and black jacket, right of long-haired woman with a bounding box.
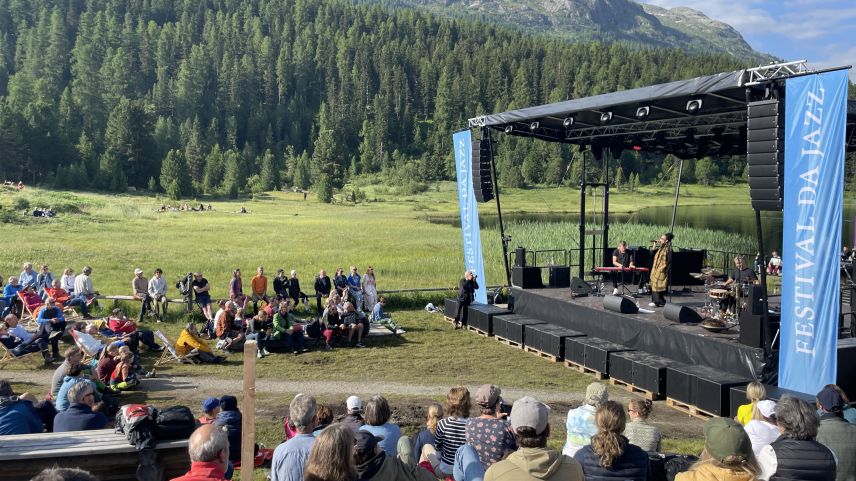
[354,431,437,481]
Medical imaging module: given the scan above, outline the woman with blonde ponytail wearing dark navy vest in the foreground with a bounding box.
[574,401,649,481]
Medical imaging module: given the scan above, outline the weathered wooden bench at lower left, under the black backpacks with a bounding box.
[0,429,190,481]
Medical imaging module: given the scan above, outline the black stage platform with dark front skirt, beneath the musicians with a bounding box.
[512,288,773,379]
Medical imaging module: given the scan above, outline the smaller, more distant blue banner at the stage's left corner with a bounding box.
[452,129,487,304]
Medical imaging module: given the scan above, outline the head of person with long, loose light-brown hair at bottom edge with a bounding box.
[303,423,357,481]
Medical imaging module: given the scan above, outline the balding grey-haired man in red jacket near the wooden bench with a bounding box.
[171,424,229,481]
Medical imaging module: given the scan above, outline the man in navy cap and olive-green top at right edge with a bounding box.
[817,384,856,481]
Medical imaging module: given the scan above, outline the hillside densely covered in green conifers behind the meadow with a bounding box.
[0,0,740,198]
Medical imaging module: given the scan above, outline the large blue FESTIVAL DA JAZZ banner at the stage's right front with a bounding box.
[779,70,847,395]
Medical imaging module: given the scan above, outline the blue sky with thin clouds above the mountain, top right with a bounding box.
[640,0,856,82]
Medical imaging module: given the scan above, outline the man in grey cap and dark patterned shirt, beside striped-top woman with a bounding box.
[466,384,517,469]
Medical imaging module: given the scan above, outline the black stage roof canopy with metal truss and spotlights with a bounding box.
[469,61,856,158]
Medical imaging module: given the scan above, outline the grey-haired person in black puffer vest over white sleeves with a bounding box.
[758,396,836,481]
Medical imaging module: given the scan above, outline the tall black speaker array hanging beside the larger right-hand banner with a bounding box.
[746,99,785,211]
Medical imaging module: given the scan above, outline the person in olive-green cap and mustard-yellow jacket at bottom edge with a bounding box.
[675,418,764,481]
